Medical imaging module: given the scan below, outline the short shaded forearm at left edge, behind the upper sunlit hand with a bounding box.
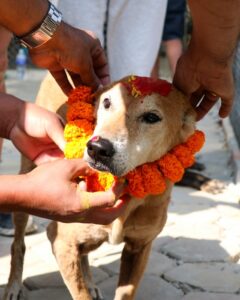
[0,93,25,139]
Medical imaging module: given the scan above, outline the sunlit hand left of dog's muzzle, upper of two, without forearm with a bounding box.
[9,101,65,165]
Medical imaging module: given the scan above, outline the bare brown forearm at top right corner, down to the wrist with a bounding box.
[189,0,240,62]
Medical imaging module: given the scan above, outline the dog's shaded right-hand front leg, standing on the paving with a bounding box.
[114,242,152,300]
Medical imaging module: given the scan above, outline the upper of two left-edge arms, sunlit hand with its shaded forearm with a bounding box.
[0,93,65,164]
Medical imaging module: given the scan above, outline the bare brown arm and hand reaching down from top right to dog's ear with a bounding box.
[173,0,240,119]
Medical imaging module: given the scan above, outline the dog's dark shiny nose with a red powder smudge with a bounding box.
[87,137,115,160]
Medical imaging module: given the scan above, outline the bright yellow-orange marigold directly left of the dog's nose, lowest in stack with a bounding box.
[64,137,89,159]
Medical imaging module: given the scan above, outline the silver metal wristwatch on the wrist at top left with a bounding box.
[18,3,62,48]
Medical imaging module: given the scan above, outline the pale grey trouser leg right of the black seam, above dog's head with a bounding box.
[107,0,167,80]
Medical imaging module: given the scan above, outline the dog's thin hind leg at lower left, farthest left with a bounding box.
[3,213,28,300]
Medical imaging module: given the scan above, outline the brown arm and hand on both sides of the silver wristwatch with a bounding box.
[0,0,109,94]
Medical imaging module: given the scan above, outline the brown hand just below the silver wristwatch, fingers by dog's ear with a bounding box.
[29,22,109,95]
